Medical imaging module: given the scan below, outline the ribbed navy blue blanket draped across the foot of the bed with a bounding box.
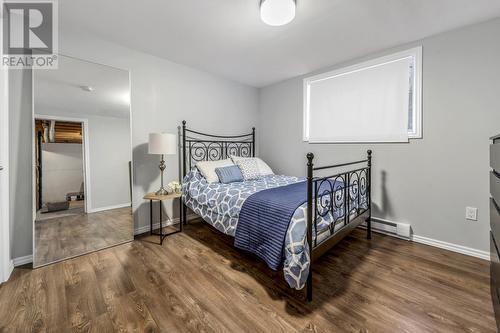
[234,182,307,270]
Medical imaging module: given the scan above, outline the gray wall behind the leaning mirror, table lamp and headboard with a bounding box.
[10,27,258,258]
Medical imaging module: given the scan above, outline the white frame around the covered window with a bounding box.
[302,46,423,143]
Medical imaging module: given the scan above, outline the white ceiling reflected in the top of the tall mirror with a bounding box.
[34,56,130,118]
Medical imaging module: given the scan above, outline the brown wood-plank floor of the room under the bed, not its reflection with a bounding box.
[0,222,496,332]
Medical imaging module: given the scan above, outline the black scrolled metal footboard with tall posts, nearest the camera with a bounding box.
[307,150,372,301]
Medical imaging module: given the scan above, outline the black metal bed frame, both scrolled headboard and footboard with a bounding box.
[178,120,372,302]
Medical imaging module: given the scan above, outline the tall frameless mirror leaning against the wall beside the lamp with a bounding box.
[33,55,134,267]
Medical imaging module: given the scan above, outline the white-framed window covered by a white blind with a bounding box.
[304,47,422,143]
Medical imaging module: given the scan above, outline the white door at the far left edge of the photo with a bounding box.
[0,69,13,283]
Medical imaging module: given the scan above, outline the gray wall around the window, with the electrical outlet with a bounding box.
[259,19,500,251]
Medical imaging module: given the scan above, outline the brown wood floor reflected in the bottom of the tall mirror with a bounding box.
[34,207,134,266]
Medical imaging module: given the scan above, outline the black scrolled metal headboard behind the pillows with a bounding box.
[178,120,255,178]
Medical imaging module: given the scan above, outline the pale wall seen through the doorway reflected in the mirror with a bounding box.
[42,143,83,204]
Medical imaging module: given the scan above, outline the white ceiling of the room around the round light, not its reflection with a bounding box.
[59,0,500,87]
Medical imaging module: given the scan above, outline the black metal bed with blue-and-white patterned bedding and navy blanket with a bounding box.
[179,121,372,301]
